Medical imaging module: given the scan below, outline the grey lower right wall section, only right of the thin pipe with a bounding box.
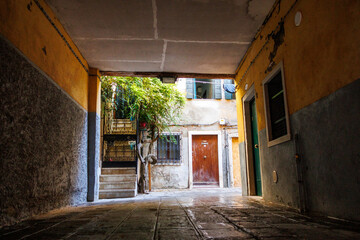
[291,79,360,221]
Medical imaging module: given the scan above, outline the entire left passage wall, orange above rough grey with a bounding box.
[0,0,93,226]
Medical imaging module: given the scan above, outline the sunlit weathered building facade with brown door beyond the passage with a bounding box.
[151,78,241,190]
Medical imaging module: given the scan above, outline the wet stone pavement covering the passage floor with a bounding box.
[0,189,360,240]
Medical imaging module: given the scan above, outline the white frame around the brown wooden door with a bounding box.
[189,131,224,189]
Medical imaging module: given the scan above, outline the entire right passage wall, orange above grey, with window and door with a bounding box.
[236,1,360,220]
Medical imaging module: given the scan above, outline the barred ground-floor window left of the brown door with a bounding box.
[157,133,181,165]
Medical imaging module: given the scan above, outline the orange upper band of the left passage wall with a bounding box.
[0,0,88,110]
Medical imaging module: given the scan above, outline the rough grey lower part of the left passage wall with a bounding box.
[0,37,88,225]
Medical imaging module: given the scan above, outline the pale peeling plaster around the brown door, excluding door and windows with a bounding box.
[151,79,237,189]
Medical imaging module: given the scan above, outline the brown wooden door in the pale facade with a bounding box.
[192,135,219,186]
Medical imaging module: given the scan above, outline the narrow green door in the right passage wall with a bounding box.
[250,99,262,196]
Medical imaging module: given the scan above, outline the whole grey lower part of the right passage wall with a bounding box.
[259,79,360,221]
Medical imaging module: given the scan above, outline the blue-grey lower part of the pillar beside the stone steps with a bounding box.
[87,112,100,202]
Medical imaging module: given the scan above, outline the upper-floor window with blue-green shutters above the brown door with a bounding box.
[186,78,221,99]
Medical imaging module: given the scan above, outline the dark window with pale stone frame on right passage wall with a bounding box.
[263,64,290,147]
